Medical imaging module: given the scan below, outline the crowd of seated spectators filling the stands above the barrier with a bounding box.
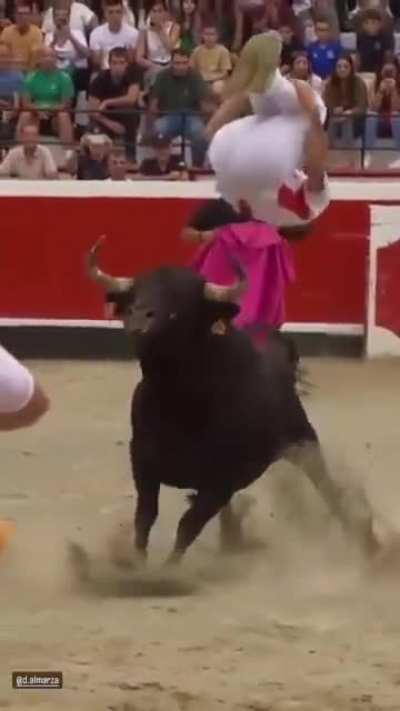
[0,0,400,180]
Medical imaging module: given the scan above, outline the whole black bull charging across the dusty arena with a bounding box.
[88,243,377,561]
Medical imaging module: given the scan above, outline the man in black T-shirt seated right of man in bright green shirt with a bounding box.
[89,47,142,159]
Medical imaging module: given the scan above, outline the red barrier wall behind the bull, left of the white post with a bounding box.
[0,195,369,324]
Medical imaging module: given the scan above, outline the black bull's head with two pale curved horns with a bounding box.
[87,238,246,356]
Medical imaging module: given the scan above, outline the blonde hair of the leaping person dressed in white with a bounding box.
[223,31,282,99]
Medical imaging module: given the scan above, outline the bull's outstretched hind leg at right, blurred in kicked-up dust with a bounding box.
[285,441,379,556]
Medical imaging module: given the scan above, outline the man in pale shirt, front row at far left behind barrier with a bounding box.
[0,125,58,180]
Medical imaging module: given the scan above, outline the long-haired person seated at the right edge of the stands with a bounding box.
[365,62,400,150]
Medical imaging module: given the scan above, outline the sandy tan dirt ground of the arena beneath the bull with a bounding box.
[0,360,400,711]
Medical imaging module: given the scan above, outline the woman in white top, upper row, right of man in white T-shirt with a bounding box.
[137,1,180,88]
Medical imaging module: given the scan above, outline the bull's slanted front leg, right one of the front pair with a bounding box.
[167,491,232,563]
